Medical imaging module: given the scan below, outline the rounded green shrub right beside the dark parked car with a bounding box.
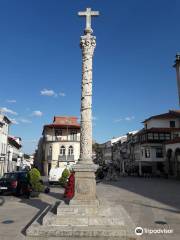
[29,168,44,192]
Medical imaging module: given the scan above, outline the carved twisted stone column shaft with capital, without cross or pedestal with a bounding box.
[80,33,96,163]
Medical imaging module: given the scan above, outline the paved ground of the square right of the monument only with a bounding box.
[97,177,180,240]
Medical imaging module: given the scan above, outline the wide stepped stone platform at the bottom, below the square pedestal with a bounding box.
[26,201,137,240]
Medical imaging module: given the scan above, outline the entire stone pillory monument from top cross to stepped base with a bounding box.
[26,8,136,240]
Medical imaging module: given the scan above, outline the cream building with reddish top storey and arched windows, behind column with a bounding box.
[35,116,80,176]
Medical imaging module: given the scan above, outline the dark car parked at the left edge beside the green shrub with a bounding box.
[0,171,32,197]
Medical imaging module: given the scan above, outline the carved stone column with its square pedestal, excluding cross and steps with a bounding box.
[71,29,97,204]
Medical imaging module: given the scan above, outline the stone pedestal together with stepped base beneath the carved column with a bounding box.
[26,161,136,240]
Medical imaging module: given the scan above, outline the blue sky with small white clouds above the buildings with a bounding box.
[0,0,180,153]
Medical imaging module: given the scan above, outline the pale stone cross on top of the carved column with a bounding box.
[78,8,99,33]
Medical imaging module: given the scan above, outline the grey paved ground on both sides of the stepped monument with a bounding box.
[0,177,180,240]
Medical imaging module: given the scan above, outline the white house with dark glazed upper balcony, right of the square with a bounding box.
[132,110,180,175]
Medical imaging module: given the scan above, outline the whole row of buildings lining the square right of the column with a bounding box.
[97,110,180,178]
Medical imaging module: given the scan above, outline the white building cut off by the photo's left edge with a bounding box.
[0,114,11,176]
